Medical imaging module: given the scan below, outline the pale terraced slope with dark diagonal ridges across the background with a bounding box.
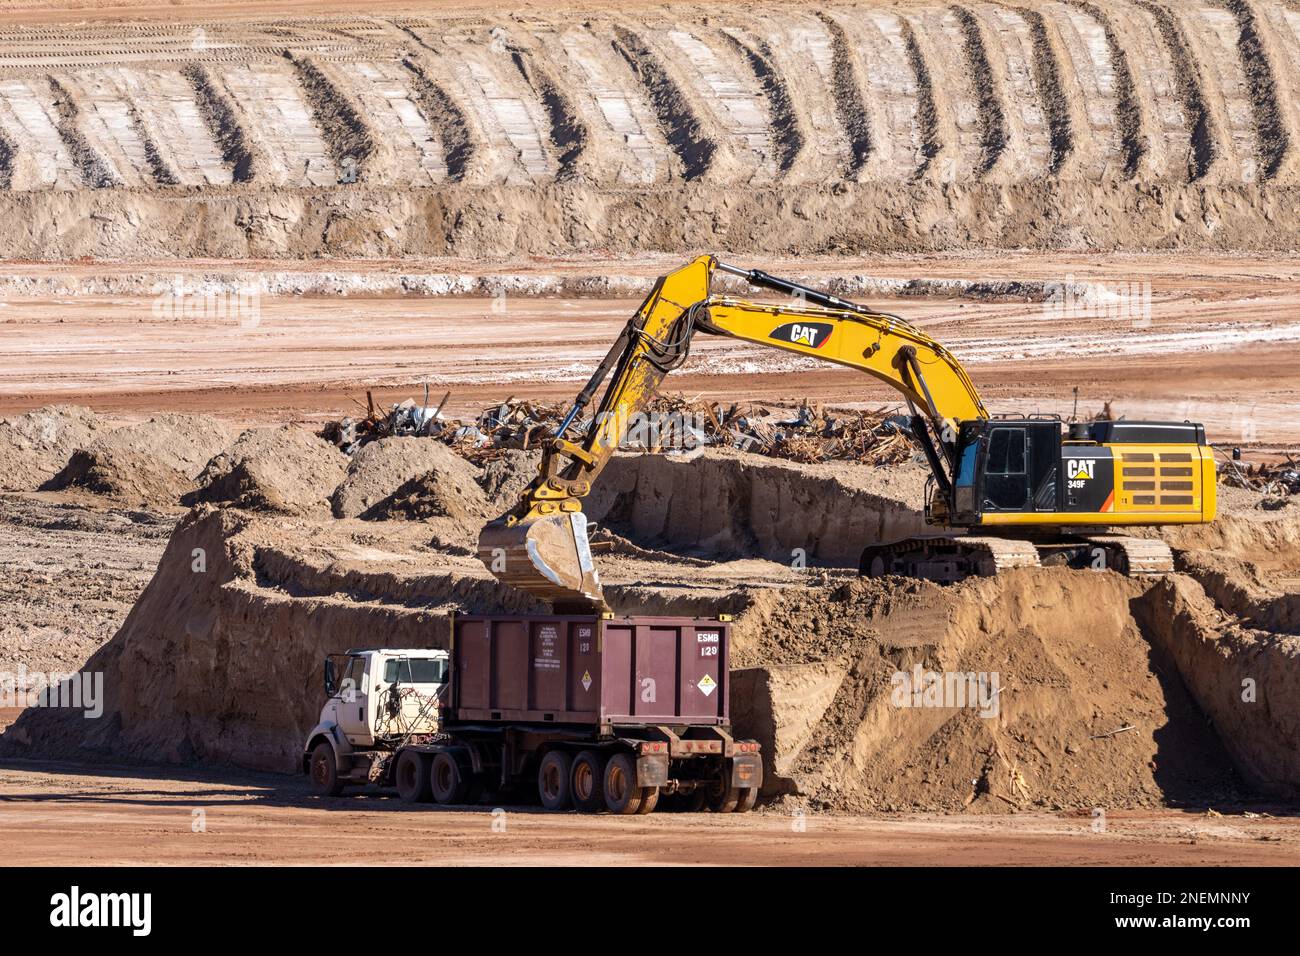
[0,0,1300,256]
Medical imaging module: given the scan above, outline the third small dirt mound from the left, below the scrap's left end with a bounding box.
[182,425,347,512]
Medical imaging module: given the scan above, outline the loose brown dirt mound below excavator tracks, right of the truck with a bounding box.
[733,568,1248,812]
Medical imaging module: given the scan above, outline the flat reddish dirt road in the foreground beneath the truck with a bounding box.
[0,762,1300,866]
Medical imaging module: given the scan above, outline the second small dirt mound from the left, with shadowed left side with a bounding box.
[44,414,230,506]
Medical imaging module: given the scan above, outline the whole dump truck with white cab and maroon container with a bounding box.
[303,614,763,814]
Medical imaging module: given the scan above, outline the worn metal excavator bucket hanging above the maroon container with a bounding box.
[478,511,608,614]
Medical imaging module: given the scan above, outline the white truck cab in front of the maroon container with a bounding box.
[303,648,451,793]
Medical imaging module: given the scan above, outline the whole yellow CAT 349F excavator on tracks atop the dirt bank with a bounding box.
[478,255,1216,613]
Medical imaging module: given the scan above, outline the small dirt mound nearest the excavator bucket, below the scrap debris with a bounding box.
[334,437,486,520]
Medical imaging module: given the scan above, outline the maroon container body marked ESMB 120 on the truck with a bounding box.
[451,615,731,727]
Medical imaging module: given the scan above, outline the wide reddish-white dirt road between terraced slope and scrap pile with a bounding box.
[0,256,1300,445]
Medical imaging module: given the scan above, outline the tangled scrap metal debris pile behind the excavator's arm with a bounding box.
[321,393,914,464]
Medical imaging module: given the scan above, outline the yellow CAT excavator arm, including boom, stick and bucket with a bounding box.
[478,256,988,611]
